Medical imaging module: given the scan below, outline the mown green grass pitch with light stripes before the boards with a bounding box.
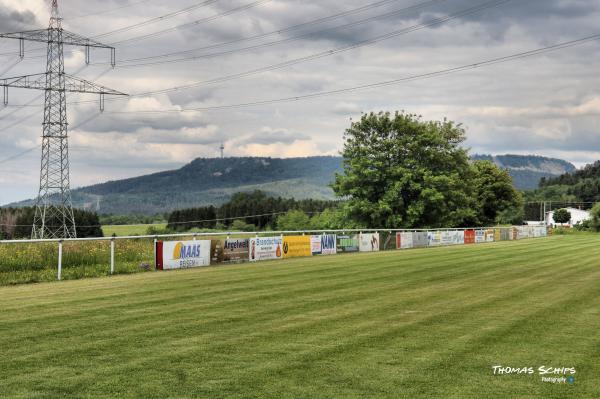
[0,235,600,398]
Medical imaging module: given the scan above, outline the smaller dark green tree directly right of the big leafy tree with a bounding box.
[473,161,523,226]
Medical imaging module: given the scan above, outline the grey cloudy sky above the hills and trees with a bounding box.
[0,0,600,204]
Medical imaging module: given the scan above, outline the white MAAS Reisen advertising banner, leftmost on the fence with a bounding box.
[156,240,211,270]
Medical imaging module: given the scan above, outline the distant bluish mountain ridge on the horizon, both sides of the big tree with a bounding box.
[5,155,575,215]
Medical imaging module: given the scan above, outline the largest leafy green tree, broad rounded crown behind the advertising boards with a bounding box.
[333,112,478,228]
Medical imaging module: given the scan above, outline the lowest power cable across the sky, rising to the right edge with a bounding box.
[108,34,600,114]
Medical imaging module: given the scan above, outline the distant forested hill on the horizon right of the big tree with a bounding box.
[471,155,576,190]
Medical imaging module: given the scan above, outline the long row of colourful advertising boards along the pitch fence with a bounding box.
[155,226,547,270]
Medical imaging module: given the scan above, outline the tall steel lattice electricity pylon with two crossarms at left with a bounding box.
[0,0,126,239]
